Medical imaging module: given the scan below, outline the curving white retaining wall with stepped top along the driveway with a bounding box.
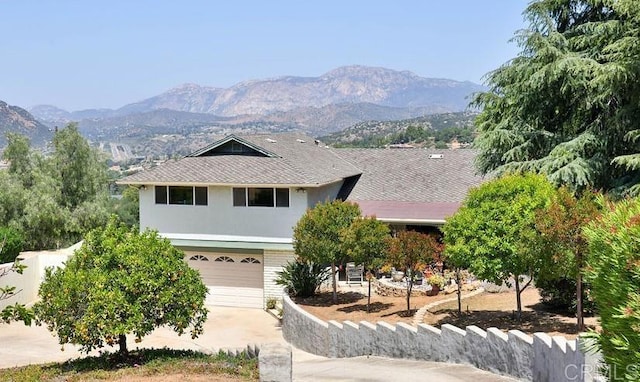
[282,296,599,382]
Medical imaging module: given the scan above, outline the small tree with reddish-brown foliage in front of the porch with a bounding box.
[387,231,442,314]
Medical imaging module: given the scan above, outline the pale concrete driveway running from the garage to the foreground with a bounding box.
[0,307,513,382]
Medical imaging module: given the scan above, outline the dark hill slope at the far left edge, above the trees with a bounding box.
[0,101,53,146]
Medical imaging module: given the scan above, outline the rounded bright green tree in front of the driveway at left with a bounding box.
[34,218,207,353]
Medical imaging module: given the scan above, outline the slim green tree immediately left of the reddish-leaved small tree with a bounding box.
[342,216,389,313]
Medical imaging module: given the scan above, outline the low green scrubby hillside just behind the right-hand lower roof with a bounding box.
[320,111,477,147]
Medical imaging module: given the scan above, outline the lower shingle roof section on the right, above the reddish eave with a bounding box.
[335,149,483,222]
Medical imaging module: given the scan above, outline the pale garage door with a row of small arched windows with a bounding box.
[187,252,264,308]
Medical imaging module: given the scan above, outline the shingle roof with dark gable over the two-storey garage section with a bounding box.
[119,134,361,186]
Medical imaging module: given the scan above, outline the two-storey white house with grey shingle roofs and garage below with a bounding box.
[119,134,481,308]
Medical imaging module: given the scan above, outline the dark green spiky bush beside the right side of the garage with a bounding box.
[276,260,329,297]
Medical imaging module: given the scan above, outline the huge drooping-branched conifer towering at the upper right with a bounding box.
[473,0,640,194]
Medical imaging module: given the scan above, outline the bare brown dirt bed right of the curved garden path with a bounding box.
[423,288,597,338]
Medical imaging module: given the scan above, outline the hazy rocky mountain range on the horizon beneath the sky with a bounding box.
[30,66,484,139]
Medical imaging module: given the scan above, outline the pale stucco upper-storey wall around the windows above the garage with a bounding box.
[140,186,337,238]
